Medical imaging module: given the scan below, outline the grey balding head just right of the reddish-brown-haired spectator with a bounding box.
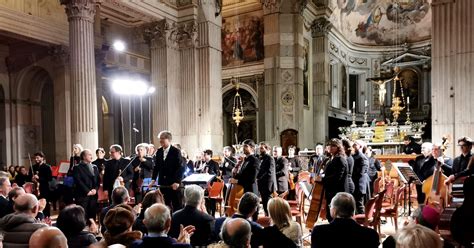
[143,203,171,233]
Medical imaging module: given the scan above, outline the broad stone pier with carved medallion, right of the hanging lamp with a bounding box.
[262,0,307,145]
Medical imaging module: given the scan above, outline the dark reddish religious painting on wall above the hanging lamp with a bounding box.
[222,12,264,67]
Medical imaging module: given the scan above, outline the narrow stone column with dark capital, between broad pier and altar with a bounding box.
[311,16,331,144]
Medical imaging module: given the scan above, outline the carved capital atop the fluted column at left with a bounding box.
[60,0,100,22]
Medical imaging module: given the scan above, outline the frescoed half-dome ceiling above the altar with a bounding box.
[330,0,432,46]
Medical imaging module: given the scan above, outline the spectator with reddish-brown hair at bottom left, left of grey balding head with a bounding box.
[91,205,142,247]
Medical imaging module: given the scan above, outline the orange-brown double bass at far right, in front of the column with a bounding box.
[423,136,448,209]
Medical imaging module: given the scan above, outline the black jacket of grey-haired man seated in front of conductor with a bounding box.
[168,206,214,246]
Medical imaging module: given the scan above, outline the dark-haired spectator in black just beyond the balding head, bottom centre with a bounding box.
[214,192,263,247]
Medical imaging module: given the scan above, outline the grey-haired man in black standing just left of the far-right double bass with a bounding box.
[408,142,437,204]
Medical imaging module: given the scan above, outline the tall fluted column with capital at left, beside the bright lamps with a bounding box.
[61,0,99,149]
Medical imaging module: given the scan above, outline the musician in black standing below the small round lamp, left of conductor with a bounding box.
[104,144,133,202]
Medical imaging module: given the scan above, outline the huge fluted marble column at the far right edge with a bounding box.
[431,0,474,156]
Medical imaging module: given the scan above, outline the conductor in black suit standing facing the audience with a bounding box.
[149,131,184,212]
